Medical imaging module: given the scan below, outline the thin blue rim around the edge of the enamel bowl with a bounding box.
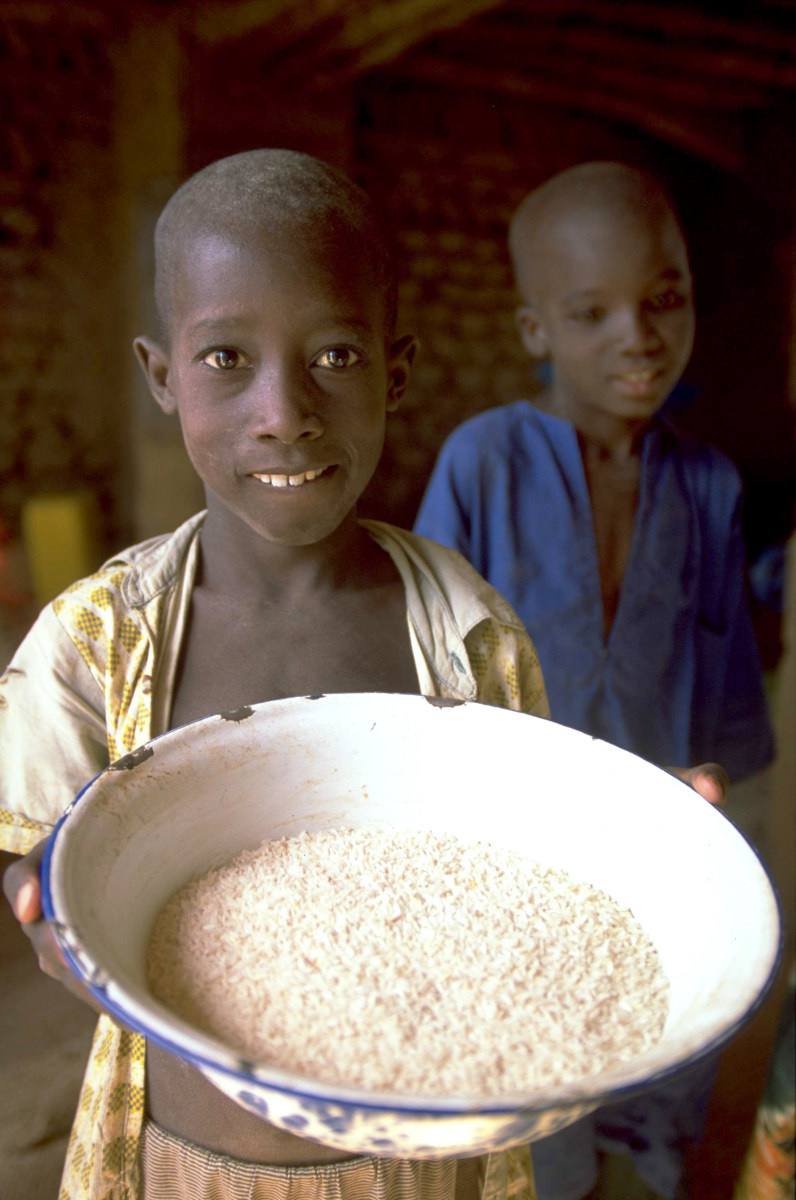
[40,734,784,1117]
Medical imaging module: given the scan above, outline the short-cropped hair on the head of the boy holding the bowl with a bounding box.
[155,150,396,338]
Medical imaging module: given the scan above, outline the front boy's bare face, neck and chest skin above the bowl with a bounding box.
[136,165,418,724]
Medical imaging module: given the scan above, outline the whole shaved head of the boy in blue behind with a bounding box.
[509,162,694,424]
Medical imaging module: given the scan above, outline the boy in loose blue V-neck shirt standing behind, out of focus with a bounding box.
[415,162,773,1200]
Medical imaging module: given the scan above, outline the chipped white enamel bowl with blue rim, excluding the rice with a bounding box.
[42,694,779,1158]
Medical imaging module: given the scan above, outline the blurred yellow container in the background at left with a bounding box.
[22,490,101,605]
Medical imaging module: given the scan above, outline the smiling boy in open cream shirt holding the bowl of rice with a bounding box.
[0,150,547,1200]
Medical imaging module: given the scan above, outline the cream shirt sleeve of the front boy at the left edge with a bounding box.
[0,606,108,854]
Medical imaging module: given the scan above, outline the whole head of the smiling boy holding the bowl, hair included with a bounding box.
[136,150,413,545]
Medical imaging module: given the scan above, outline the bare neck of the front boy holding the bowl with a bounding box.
[197,508,391,604]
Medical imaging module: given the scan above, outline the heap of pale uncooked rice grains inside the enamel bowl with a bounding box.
[148,827,669,1097]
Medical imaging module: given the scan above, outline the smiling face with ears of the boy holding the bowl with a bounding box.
[136,223,413,546]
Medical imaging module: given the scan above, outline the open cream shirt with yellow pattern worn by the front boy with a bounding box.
[0,514,547,1200]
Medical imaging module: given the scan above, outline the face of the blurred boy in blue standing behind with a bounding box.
[519,209,694,424]
